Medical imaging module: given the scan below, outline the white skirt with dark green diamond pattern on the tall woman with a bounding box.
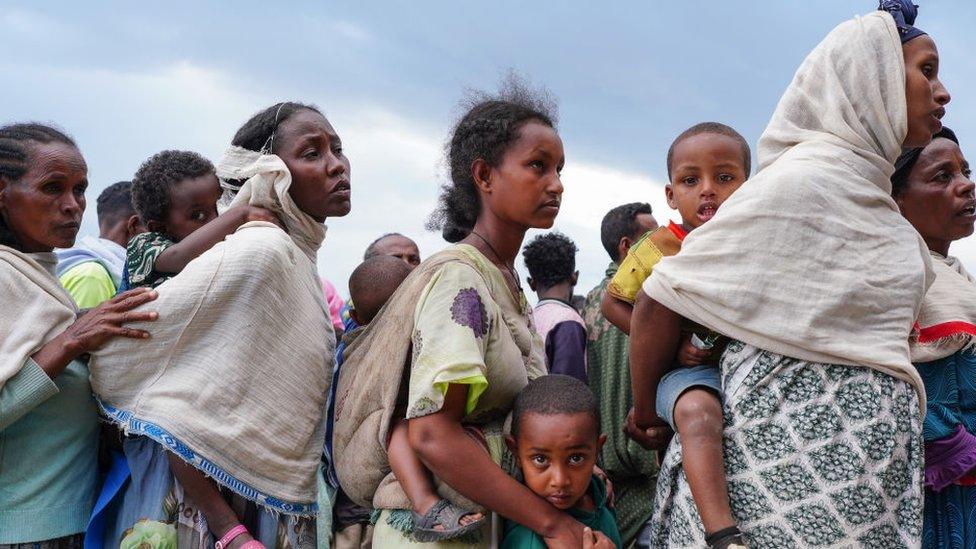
[640,341,923,549]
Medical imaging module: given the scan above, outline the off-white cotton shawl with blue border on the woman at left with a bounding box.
[90,147,334,514]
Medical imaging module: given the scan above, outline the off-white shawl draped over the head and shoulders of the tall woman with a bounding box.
[644,12,932,410]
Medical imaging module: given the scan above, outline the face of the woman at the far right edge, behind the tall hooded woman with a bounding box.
[895,137,976,250]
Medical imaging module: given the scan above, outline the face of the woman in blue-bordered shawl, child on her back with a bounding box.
[275,109,352,221]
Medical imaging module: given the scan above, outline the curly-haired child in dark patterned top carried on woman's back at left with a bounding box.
[125,151,280,548]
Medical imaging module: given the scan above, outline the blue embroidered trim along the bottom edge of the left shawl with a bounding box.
[95,397,319,515]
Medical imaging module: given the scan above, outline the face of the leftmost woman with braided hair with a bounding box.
[0,142,88,253]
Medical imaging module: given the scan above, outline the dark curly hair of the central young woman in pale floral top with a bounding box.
[427,73,557,242]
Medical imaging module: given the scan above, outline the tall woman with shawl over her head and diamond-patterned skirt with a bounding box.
[631,2,949,547]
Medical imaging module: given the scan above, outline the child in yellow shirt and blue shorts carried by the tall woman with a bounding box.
[602,122,751,549]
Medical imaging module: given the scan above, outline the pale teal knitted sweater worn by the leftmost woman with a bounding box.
[0,359,98,544]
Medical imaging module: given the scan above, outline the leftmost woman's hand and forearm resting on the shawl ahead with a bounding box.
[31,288,159,379]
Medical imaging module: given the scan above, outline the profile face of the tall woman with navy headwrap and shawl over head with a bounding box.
[902,35,950,148]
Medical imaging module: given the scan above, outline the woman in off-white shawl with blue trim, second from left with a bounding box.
[91,102,351,548]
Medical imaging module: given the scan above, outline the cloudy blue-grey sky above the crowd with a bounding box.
[0,0,976,300]
